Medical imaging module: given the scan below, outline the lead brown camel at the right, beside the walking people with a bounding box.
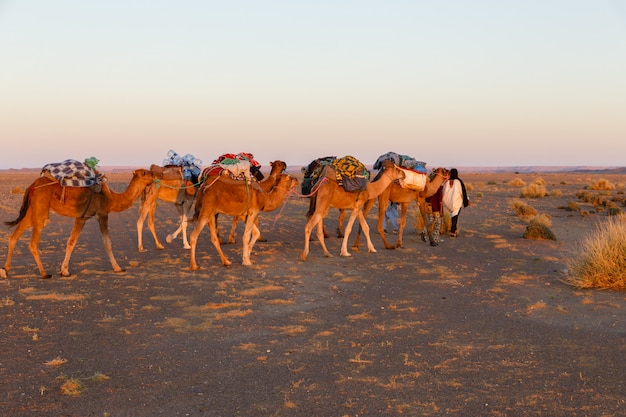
[352,168,449,250]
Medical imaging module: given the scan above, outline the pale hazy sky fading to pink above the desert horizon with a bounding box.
[0,0,626,169]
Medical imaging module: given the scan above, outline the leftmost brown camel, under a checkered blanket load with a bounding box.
[0,169,155,278]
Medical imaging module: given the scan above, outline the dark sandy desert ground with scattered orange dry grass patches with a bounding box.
[0,167,626,417]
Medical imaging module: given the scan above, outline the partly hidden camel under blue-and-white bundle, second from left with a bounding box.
[137,165,196,252]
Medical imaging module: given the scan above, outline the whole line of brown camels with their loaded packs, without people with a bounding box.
[0,151,448,278]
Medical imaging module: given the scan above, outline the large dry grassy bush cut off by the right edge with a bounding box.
[564,215,626,290]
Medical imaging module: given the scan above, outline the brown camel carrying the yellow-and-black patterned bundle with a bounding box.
[301,161,405,261]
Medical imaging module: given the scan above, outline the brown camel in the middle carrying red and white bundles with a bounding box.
[189,173,298,270]
